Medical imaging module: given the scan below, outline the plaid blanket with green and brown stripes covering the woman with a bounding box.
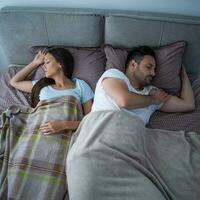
[0,96,82,200]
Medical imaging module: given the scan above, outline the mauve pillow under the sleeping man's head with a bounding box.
[104,41,186,94]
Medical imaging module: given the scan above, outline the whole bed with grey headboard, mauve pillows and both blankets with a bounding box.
[0,7,200,200]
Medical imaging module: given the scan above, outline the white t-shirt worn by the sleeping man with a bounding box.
[92,69,161,124]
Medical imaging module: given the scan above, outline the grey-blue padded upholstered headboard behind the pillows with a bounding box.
[0,7,200,74]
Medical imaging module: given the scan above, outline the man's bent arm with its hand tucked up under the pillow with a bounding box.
[160,67,195,112]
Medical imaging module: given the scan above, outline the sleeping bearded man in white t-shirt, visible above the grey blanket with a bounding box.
[92,46,195,125]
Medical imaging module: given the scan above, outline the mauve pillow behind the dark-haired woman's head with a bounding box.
[30,46,106,91]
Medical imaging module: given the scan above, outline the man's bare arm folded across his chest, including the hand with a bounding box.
[102,78,168,109]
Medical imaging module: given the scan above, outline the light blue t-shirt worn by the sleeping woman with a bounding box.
[32,78,94,104]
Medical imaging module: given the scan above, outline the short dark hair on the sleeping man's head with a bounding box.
[125,46,156,70]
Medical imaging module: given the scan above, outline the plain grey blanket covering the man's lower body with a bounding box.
[67,111,200,200]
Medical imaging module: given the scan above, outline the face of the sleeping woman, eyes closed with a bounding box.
[43,53,62,78]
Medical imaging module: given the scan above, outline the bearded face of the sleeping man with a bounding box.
[134,55,156,86]
